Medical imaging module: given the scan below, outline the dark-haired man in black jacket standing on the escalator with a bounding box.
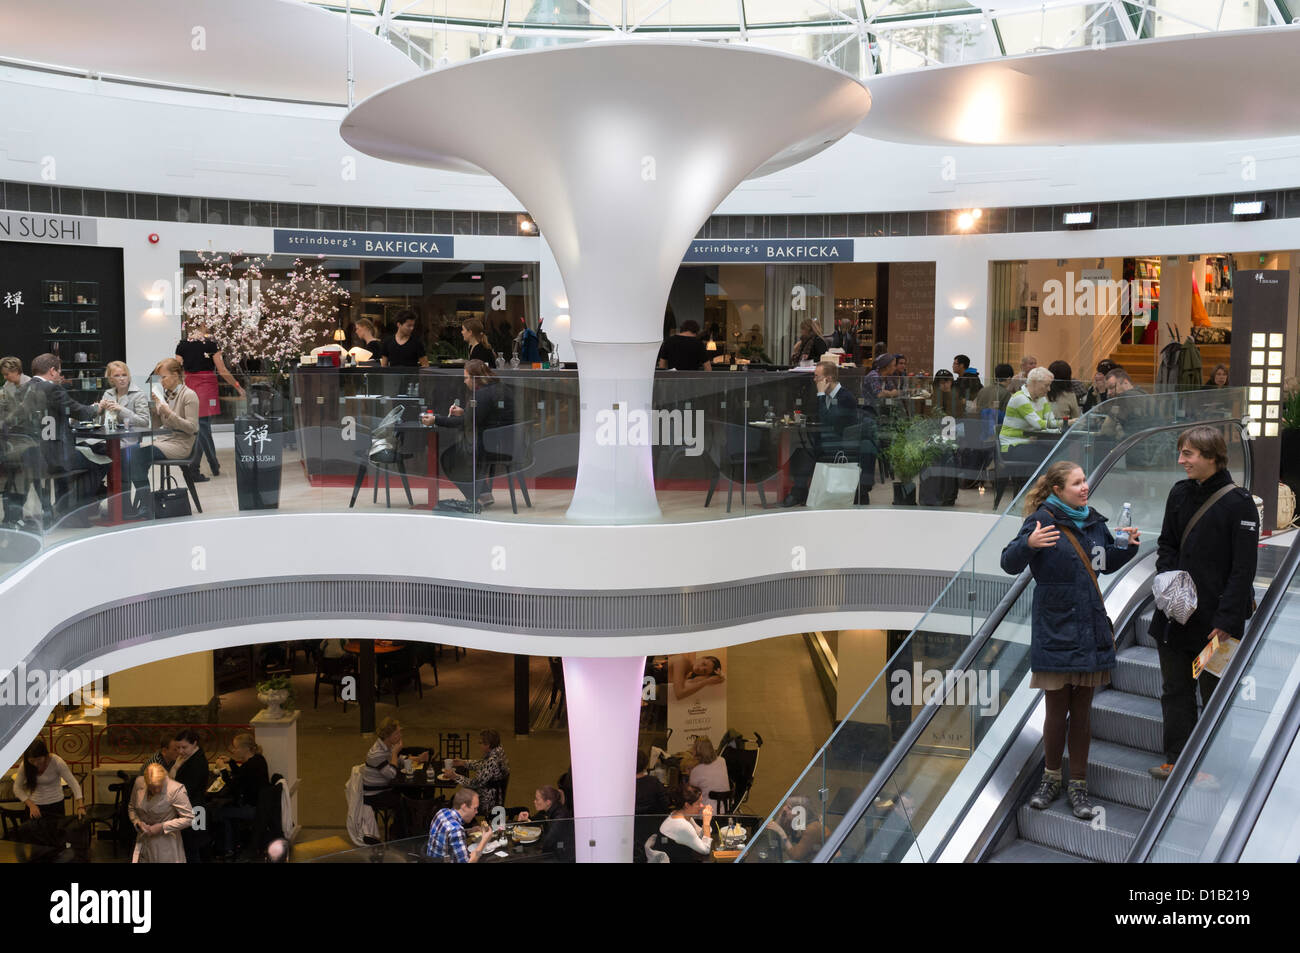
[1151,426,1260,780]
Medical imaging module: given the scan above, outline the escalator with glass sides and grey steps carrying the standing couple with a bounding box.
[742,391,1284,862]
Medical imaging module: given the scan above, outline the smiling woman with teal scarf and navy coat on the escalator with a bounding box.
[1002,460,1138,819]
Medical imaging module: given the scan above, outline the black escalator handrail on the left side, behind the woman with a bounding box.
[813,417,1251,863]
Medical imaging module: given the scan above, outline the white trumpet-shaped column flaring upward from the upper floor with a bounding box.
[341,42,871,523]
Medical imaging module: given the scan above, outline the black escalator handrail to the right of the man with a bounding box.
[1126,527,1300,863]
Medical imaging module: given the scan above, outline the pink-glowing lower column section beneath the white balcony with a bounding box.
[564,655,646,863]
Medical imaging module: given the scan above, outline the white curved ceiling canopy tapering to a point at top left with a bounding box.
[0,0,420,103]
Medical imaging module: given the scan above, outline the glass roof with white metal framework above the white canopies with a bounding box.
[304,0,1300,78]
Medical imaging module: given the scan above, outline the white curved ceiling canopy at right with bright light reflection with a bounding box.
[855,26,1300,146]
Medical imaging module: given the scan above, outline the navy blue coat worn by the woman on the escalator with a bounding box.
[1002,503,1139,672]
